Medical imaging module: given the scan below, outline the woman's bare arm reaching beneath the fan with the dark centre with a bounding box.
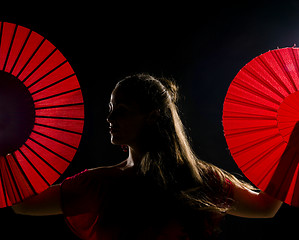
[12,185,62,216]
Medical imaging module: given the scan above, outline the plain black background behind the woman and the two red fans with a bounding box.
[0,1,299,240]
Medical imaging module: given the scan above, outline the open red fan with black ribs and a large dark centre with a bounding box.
[0,22,84,207]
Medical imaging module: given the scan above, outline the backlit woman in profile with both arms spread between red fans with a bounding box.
[13,74,282,240]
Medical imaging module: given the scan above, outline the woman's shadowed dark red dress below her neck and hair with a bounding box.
[61,162,231,240]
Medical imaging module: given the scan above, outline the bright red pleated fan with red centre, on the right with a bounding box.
[223,48,299,206]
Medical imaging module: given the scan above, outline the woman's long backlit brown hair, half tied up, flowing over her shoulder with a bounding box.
[115,74,253,212]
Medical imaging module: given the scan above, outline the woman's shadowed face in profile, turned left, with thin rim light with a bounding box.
[107,88,147,146]
